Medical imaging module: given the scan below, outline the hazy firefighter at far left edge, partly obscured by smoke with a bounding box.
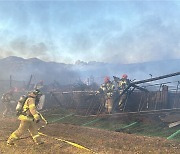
[1,89,15,118]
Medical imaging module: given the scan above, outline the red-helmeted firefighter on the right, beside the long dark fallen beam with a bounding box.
[117,74,130,110]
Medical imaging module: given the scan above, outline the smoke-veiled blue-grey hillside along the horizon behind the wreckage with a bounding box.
[0,56,180,84]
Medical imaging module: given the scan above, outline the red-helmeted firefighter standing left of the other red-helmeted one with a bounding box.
[97,76,115,113]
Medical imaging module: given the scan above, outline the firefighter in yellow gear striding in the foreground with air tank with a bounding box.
[7,89,43,145]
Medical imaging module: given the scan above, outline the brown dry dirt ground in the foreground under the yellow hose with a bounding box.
[0,118,180,154]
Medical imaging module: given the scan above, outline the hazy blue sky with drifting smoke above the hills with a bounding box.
[0,0,180,63]
